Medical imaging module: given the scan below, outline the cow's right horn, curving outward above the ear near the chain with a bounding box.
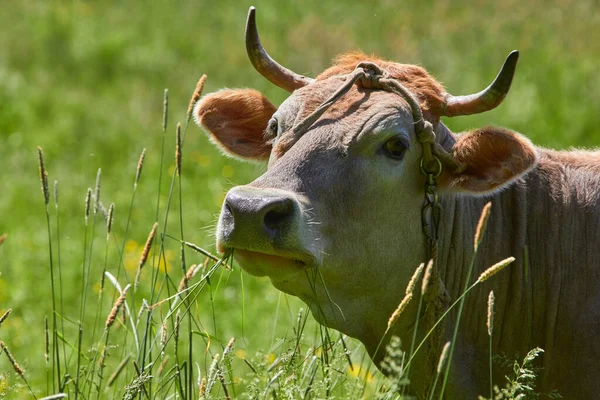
[442,50,519,117]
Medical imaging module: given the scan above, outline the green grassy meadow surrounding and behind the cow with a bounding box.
[0,0,600,399]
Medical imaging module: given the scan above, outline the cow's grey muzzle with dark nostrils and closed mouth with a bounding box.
[217,186,315,275]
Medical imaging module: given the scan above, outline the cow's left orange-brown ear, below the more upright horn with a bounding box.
[194,89,277,161]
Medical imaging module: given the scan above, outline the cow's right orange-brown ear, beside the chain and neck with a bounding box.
[440,127,538,194]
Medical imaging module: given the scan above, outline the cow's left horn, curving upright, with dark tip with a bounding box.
[246,7,313,93]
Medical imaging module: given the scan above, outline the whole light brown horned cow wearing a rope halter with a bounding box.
[194,8,600,399]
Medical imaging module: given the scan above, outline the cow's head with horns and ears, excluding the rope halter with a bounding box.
[194,5,535,352]
